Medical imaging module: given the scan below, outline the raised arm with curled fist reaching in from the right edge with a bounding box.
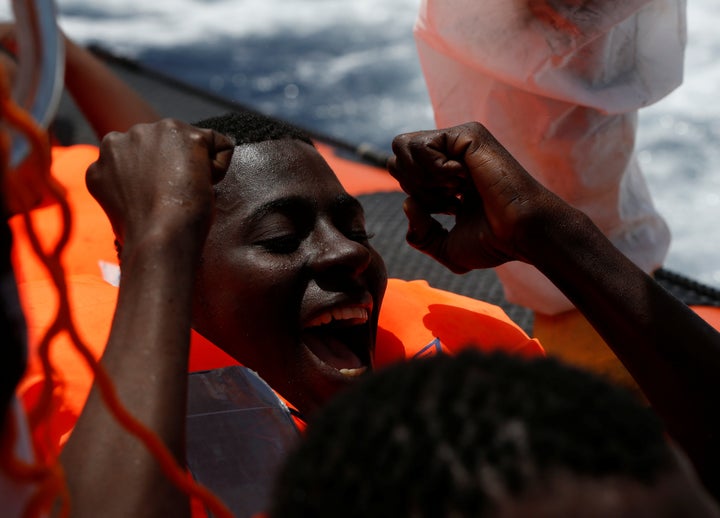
[389,123,720,497]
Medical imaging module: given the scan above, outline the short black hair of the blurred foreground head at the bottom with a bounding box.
[270,351,673,518]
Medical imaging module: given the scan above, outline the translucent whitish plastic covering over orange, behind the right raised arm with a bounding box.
[415,0,686,314]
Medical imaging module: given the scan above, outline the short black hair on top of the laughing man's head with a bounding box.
[195,110,314,146]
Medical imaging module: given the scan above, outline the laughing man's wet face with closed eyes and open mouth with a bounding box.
[193,139,387,413]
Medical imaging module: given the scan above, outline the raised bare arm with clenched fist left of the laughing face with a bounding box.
[61,120,233,516]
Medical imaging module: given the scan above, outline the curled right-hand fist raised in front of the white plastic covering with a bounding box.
[388,123,573,273]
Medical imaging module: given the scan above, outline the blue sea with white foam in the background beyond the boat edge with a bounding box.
[8,0,720,288]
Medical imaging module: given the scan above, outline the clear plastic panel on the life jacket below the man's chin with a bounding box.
[187,366,300,518]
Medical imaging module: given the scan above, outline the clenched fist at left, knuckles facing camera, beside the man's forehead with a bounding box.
[85,119,234,262]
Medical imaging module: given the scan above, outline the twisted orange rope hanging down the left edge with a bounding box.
[0,60,232,518]
